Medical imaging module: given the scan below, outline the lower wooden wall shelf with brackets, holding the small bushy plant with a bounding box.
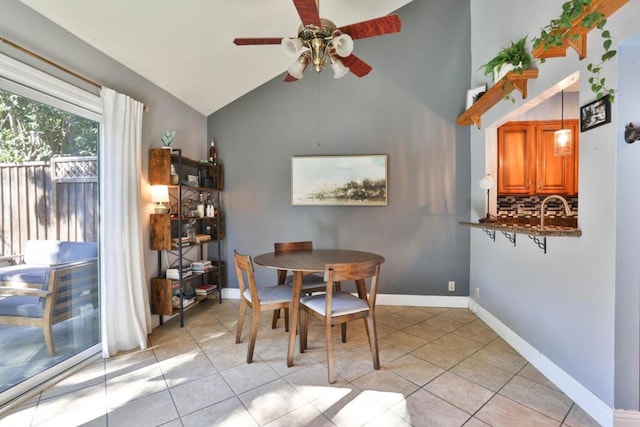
[456,69,538,129]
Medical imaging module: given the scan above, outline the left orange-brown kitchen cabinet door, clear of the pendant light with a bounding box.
[498,124,535,194]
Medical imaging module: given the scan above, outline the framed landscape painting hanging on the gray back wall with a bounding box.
[291,154,387,206]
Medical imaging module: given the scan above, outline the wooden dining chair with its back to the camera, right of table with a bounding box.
[300,260,381,383]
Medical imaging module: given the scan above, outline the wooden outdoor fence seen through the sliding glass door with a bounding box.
[0,156,98,256]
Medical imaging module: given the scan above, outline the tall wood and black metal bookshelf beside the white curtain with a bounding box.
[149,149,226,326]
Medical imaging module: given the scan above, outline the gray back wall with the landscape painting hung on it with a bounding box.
[208,0,470,295]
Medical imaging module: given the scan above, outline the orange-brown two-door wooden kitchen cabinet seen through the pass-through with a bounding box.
[498,120,579,195]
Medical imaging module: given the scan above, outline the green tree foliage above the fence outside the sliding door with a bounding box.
[0,90,99,163]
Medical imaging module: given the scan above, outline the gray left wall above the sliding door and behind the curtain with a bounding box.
[0,0,206,314]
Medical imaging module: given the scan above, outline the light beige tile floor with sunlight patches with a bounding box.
[0,300,598,427]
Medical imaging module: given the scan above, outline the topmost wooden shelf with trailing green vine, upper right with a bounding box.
[533,0,625,102]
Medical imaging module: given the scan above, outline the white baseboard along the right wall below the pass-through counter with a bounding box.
[469,299,616,427]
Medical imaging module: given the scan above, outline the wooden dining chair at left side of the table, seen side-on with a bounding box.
[233,250,293,363]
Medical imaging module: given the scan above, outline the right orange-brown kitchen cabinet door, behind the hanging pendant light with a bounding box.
[535,120,578,194]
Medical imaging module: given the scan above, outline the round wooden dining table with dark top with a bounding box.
[253,249,384,366]
